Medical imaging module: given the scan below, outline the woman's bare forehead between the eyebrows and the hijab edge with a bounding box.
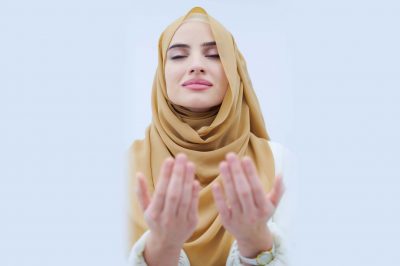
[171,21,214,44]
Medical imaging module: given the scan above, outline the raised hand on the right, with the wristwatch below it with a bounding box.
[212,152,285,257]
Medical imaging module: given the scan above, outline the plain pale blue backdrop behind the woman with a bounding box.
[0,0,400,266]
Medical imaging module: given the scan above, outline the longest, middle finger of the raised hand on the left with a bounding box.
[163,153,187,216]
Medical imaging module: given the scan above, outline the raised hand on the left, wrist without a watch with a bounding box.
[137,153,200,249]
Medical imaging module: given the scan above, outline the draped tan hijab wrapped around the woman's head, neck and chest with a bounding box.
[128,7,275,266]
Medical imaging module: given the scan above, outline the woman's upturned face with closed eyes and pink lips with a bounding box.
[165,21,228,112]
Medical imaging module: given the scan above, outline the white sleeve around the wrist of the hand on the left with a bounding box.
[128,230,190,266]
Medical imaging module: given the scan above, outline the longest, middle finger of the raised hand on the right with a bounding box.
[227,152,255,215]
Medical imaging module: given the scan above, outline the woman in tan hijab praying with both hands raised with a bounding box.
[128,7,296,266]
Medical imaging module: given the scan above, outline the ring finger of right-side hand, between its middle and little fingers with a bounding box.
[219,161,242,215]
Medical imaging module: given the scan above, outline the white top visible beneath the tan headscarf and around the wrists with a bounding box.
[128,141,298,266]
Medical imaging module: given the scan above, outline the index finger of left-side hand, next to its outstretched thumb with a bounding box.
[151,157,175,215]
